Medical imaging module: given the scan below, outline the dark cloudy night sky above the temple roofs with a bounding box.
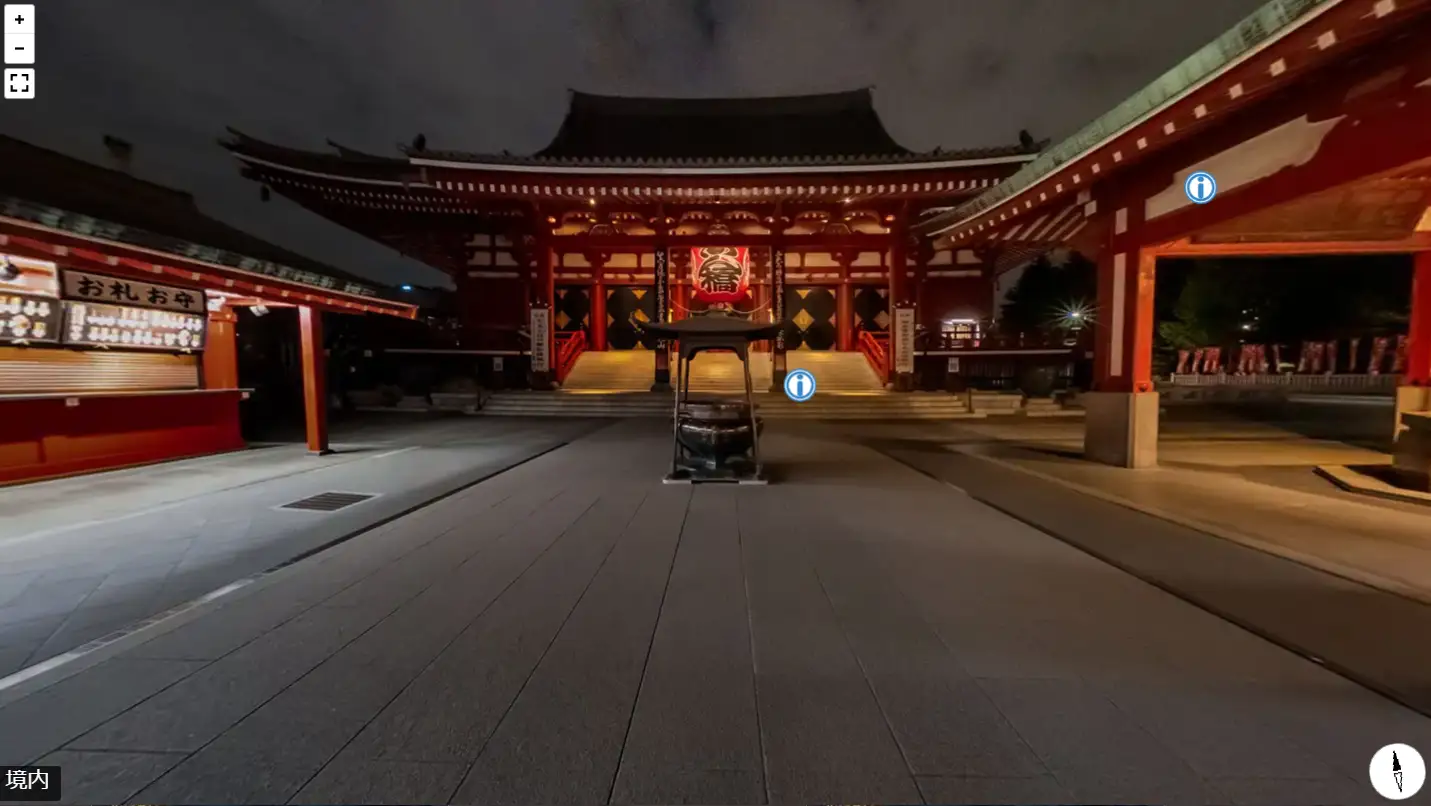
[8,0,1261,290]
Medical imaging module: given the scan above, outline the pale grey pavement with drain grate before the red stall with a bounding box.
[0,418,592,677]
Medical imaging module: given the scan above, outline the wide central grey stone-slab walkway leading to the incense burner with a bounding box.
[0,422,1431,805]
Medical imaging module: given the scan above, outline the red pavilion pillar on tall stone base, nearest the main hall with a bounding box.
[1083,202,1158,468]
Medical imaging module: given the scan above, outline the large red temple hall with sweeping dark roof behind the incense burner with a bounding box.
[226,90,1053,388]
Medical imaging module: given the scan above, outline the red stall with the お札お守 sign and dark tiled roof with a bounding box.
[0,137,416,484]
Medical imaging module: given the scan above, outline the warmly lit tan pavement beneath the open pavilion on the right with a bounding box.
[926,422,1431,604]
